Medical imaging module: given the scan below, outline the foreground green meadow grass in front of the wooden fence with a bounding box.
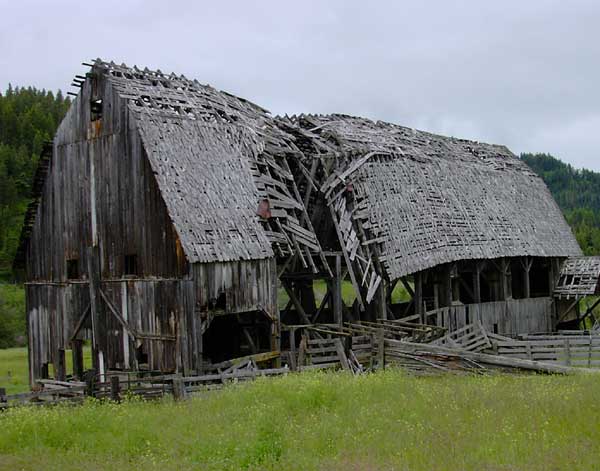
[0,370,600,471]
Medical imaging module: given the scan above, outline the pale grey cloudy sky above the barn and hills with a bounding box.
[0,0,600,170]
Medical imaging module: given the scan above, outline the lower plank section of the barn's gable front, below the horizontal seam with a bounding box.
[27,280,193,379]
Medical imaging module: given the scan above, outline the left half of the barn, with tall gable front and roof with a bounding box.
[10,60,323,380]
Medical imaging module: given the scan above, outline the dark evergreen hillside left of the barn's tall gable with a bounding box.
[0,86,70,278]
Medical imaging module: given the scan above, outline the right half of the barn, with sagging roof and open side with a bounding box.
[281,115,584,334]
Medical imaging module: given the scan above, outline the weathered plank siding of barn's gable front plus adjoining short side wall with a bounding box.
[27,71,278,381]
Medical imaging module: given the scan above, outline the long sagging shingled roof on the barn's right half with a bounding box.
[280,115,581,286]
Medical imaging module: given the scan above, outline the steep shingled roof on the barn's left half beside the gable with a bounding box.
[92,59,322,270]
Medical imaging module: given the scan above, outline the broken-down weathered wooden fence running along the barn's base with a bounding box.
[0,322,600,409]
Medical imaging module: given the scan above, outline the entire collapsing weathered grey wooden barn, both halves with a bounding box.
[15,59,592,382]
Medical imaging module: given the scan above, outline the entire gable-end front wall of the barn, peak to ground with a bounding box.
[26,70,193,379]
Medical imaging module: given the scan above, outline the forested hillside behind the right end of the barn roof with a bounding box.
[521,154,600,255]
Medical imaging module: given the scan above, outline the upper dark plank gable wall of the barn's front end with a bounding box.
[27,68,187,282]
